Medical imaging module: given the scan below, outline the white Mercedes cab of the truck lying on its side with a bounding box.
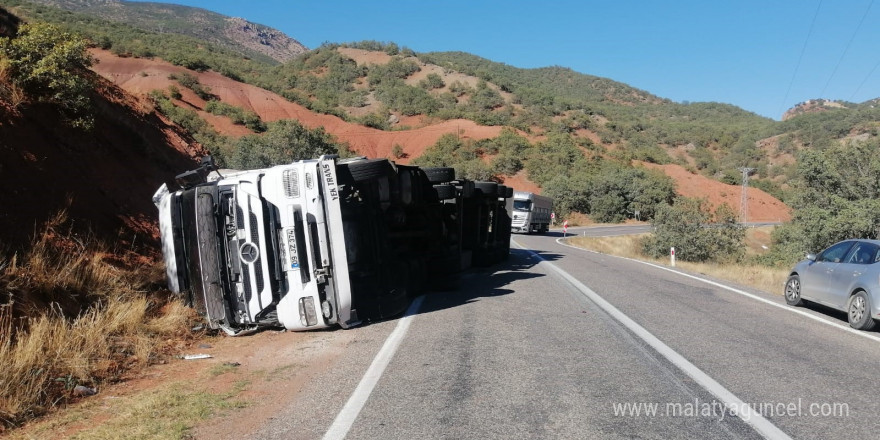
[153,156,358,333]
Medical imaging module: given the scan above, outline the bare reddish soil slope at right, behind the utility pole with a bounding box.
[642,163,791,222]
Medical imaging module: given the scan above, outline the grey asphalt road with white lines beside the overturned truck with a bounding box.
[255,226,880,439]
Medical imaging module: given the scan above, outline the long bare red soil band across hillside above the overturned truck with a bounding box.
[92,50,501,163]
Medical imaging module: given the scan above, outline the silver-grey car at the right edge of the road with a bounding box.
[785,240,880,330]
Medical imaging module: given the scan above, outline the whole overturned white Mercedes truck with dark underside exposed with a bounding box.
[153,155,513,335]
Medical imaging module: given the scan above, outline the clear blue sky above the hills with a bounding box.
[132,0,880,119]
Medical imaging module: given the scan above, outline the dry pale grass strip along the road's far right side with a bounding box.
[568,230,788,295]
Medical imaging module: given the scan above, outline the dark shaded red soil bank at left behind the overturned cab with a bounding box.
[0,75,204,251]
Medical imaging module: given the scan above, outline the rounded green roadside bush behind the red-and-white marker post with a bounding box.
[642,197,745,262]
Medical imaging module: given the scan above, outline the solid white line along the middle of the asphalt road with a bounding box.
[513,241,791,439]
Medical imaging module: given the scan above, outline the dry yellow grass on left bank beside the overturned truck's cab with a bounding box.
[0,213,193,432]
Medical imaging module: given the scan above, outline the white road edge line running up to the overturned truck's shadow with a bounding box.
[323,295,425,440]
